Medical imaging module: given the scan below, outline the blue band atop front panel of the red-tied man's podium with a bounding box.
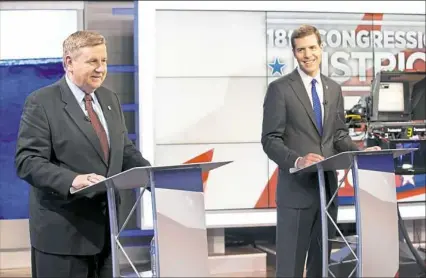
[154,168,203,192]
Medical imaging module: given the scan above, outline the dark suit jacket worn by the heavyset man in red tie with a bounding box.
[15,78,149,255]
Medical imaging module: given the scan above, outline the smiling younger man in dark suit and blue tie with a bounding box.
[261,25,378,277]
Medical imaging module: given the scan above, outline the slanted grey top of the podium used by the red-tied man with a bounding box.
[70,161,232,195]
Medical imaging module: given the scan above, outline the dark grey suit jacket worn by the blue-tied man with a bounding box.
[261,70,358,208]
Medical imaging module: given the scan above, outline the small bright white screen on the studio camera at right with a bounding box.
[378,82,404,112]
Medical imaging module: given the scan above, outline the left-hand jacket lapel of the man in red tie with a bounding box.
[59,77,108,165]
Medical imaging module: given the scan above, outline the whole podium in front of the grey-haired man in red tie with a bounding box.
[71,161,231,277]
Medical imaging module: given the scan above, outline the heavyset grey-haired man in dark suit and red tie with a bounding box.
[15,31,150,277]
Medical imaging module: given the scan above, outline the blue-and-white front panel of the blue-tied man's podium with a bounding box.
[355,154,399,277]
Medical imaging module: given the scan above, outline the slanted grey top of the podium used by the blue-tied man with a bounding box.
[290,148,418,174]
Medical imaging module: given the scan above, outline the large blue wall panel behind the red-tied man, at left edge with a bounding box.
[0,59,64,219]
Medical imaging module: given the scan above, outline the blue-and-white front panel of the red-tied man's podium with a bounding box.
[151,168,209,277]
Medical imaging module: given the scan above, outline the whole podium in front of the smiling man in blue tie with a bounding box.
[290,148,417,277]
